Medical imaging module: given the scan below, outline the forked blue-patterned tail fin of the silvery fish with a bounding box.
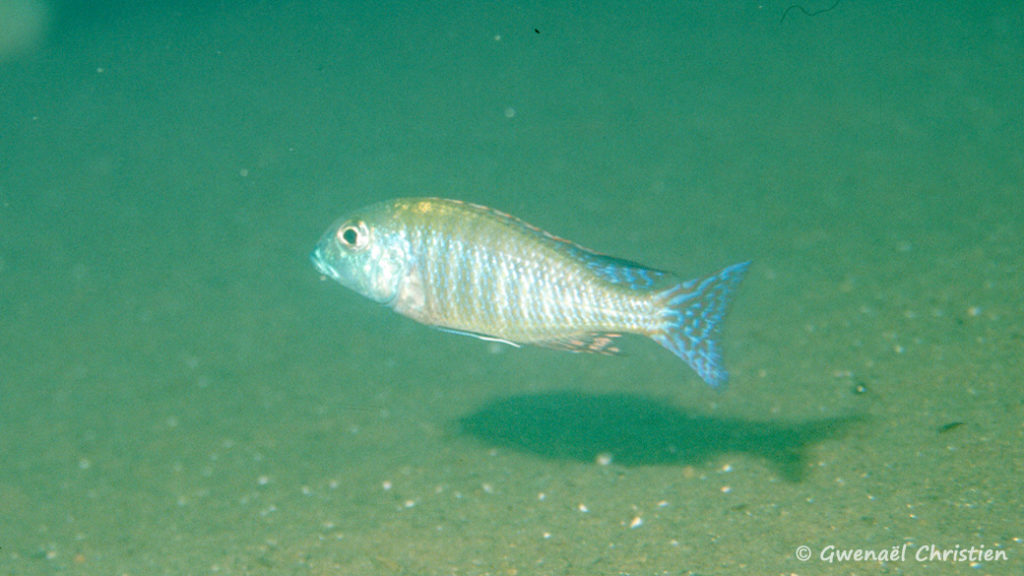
[650,262,751,388]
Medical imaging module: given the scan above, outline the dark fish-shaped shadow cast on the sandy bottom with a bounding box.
[458,392,859,482]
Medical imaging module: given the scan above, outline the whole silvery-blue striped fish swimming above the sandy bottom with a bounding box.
[310,198,751,388]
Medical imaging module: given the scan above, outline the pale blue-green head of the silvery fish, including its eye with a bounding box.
[309,208,409,304]
